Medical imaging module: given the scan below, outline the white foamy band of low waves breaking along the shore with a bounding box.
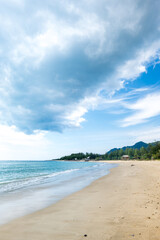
[0,163,116,193]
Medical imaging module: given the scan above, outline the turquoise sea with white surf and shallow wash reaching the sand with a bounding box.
[0,161,116,224]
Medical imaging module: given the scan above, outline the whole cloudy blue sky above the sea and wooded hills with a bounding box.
[0,0,160,160]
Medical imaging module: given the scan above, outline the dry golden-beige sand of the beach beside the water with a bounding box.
[0,161,160,240]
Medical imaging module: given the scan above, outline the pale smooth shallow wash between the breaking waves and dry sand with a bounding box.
[0,163,117,226]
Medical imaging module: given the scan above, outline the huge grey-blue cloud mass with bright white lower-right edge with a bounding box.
[0,0,160,133]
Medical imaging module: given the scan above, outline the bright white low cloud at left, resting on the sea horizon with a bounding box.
[0,125,54,160]
